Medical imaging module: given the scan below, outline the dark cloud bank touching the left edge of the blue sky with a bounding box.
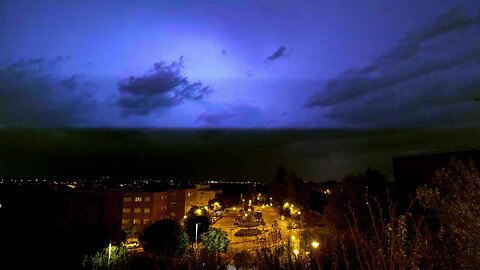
[0,57,94,127]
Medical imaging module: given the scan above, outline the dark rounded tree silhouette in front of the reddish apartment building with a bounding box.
[140,219,188,257]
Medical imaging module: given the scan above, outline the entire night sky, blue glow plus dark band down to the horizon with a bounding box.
[0,0,480,181]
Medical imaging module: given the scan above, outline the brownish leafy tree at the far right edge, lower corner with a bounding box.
[417,159,480,269]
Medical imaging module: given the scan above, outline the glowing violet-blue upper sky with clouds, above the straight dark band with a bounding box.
[0,0,480,128]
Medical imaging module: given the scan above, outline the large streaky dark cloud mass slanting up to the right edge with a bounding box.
[307,6,480,126]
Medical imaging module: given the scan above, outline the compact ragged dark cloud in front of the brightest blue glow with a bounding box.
[118,57,212,115]
